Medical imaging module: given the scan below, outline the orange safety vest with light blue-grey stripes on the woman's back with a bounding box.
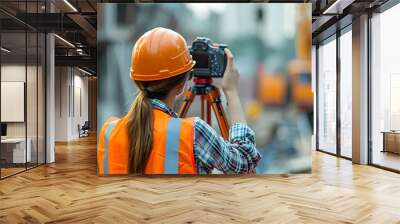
[97,109,197,174]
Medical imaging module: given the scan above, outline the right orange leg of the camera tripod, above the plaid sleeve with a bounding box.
[207,88,229,140]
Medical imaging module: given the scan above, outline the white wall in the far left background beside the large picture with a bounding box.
[55,67,88,141]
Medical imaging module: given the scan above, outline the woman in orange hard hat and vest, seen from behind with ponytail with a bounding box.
[97,28,261,174]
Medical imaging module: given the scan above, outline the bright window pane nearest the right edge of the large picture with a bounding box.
[318,39,336,153]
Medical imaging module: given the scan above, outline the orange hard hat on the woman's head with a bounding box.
[131,27,195,81]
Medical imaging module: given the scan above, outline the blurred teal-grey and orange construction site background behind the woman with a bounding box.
[97,3,314,173]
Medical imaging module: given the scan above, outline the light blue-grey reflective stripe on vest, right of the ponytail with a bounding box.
[164,118,181,174]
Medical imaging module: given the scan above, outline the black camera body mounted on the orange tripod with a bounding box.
[189,37,227,78]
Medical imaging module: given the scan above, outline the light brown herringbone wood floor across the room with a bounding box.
[0,135,400,223]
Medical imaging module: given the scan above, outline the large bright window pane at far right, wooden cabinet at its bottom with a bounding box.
[371,5,400,170]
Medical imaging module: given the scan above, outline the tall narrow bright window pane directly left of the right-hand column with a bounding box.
[340,30,352,158]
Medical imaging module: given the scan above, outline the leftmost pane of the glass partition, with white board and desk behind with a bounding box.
[0,29,27,178]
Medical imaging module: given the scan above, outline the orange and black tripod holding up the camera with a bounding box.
[179,78,229,140]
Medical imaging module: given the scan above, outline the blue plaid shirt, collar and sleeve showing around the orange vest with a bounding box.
[151,99,261,174]
